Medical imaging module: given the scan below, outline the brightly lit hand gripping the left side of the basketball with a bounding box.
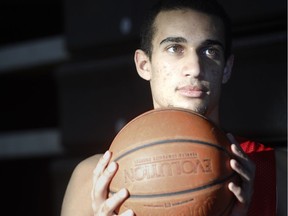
[91,151,134,216]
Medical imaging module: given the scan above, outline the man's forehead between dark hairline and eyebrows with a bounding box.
[153,9,224,44]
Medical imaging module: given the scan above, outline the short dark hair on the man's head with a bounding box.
[140,0,232,59]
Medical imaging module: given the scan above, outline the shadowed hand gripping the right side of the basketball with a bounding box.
[227,134,256,216]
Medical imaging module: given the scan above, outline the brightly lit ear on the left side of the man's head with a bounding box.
[134,49,151,81]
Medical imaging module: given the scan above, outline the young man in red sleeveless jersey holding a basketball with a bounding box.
[61,0,282,216]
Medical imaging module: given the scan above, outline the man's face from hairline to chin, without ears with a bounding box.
[149,10,230,116]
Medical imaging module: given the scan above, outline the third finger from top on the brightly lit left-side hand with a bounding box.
[100,188,129,215]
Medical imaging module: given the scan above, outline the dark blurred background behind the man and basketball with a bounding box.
[0,0,287,216]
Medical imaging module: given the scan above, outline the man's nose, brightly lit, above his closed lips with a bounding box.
[182,50,201,78]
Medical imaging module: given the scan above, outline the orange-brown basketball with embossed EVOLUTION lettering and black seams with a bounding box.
[109,108,236,216]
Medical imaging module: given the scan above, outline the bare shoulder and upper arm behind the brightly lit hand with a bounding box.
[61,154,102,216]
